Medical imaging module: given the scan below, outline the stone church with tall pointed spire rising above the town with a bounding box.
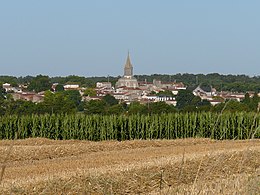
[116,52,138,88]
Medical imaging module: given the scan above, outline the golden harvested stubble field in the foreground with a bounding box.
[0,138,260,194]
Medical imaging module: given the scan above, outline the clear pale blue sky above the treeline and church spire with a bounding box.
[0,0,260,76]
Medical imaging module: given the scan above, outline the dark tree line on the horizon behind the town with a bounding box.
[0,73,260,92]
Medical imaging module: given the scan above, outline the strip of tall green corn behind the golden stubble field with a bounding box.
[0,112,260,141]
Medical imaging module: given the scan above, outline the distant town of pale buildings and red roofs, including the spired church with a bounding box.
[2,53,260,106]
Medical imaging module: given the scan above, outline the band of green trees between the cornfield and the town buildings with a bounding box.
[0,88,260,115]
